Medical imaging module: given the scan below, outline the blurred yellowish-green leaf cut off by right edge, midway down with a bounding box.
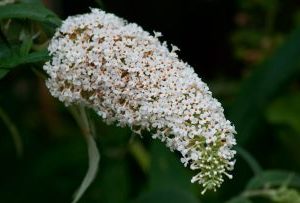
[266,94,300,133]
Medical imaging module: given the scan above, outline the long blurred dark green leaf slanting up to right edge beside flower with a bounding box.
[229,27,300,145]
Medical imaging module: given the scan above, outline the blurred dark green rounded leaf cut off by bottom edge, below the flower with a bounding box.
[133,189,199,203]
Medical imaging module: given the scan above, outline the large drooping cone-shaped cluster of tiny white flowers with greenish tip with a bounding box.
[44,9,236,193]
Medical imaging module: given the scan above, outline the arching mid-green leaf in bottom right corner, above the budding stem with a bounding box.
[246,170,300,190]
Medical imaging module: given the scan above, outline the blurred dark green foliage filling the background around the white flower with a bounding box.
[0,0,300,203]
